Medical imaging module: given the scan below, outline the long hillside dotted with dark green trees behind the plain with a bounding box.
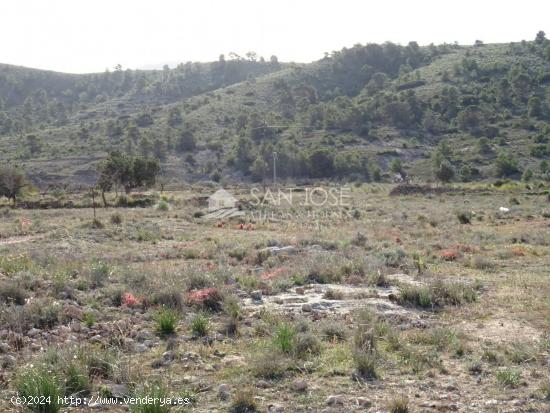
[0,33,550,185]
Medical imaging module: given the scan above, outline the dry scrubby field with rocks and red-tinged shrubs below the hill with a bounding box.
[0,184,550,412]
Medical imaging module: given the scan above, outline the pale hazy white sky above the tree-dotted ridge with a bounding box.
[0,0,550,73]
